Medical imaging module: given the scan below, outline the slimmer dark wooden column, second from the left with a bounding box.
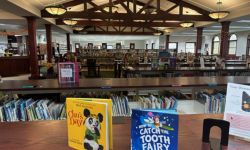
[45,24,52,63]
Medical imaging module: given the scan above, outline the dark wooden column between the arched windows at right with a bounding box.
[220,21,230,58]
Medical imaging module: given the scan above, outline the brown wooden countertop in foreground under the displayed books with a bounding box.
[0,115,250,150]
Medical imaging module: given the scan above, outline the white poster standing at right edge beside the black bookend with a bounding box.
[224,83,250,139]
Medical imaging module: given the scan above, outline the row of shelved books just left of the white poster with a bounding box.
[197,92,226,114]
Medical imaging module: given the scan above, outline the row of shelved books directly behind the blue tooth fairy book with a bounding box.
[139,95,178,110]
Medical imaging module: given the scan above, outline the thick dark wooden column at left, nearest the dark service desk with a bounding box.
[27,17,39,79]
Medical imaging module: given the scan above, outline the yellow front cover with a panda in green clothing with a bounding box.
[66,98,109,150]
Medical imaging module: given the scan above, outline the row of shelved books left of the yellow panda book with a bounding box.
[0,99,66,122]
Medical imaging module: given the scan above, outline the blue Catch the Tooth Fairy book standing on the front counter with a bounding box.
[131,109,178,150]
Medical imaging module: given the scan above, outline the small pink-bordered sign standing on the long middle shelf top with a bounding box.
[58,62,79,83]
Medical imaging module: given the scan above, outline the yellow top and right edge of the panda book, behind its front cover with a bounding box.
[69,98,113,150]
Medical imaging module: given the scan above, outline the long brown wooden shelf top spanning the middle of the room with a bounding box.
[0,76,250,93]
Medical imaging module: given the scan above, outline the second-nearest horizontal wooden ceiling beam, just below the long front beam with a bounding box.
[56,19,180,27]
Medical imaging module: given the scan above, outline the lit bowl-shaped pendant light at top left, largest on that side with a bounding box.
[44,1,67,16]
